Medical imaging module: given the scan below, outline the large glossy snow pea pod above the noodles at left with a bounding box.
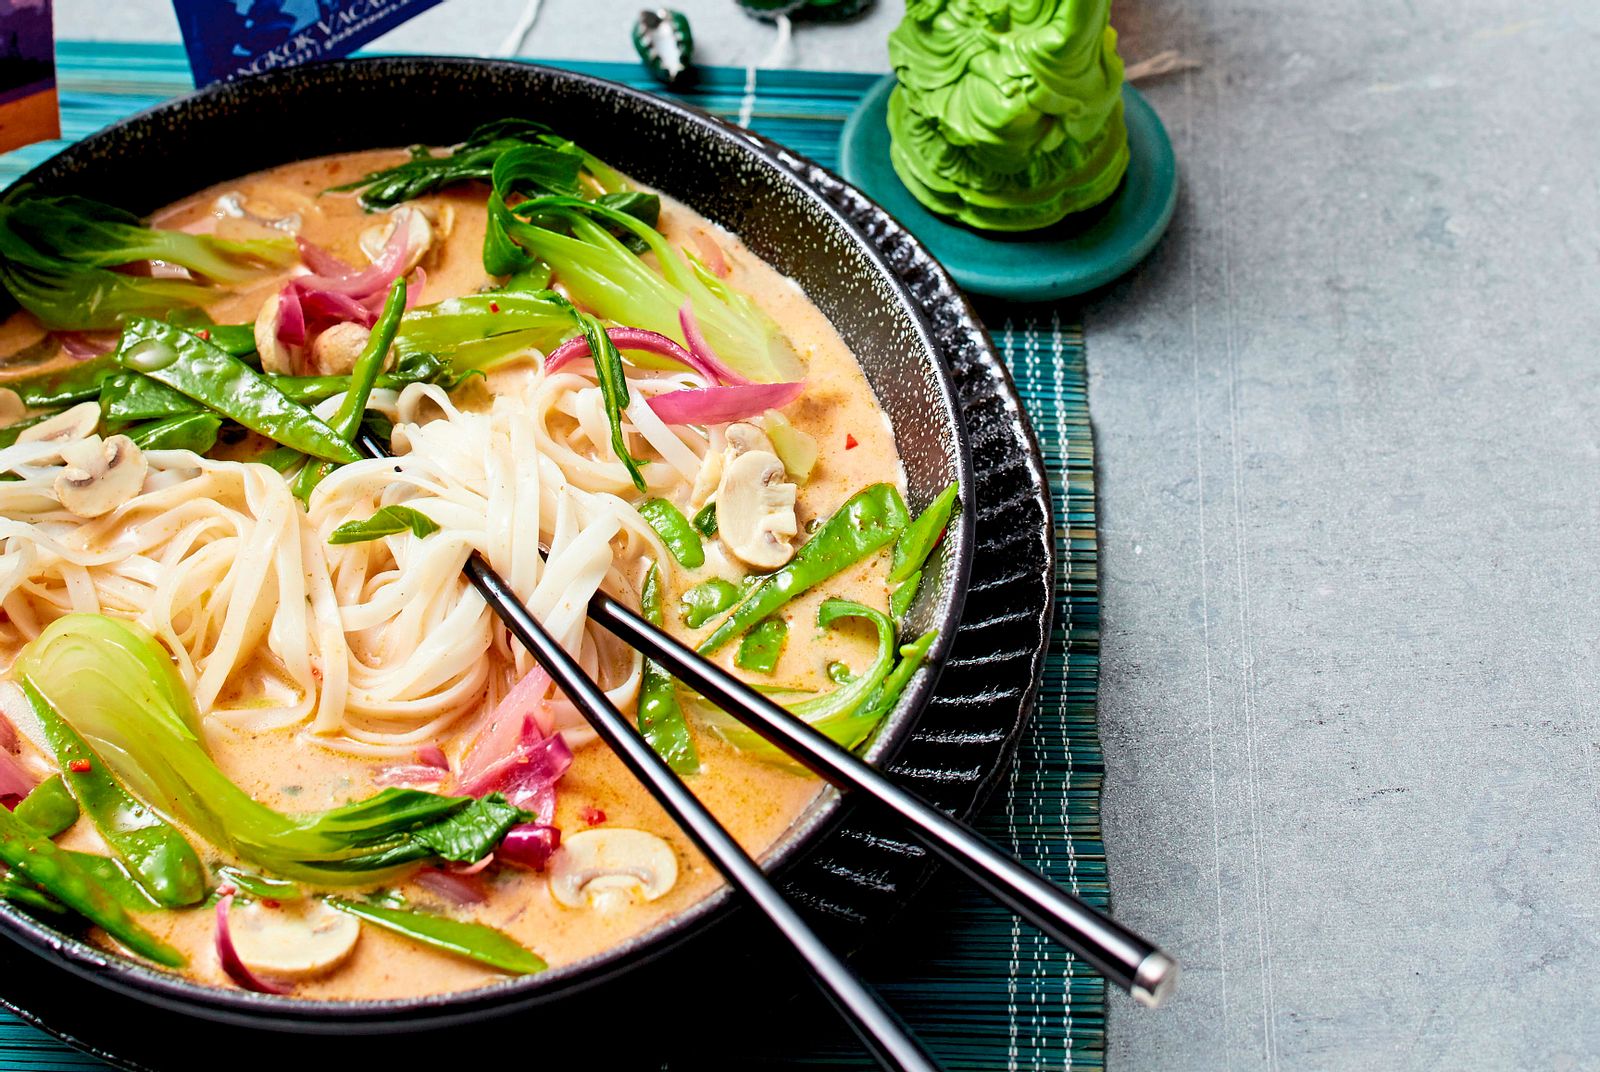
[117,317,362,462]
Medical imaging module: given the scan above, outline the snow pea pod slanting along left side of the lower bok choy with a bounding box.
[22,677,205,909]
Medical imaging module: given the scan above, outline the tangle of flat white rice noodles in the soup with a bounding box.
[0,355,720,755]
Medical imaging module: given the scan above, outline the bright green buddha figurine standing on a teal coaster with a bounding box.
[888,0,1128,230]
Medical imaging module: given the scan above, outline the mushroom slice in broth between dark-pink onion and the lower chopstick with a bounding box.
[550,826,678,912]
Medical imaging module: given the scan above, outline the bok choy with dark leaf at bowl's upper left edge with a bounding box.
[0,192,294,331]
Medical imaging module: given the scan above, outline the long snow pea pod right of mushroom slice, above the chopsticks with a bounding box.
[698,483,906,654]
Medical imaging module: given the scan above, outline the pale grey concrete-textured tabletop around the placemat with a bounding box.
[58,0,1600,1070]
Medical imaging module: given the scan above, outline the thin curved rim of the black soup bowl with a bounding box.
[0,56,976,1034]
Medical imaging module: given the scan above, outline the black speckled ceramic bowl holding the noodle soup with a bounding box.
[0,58,974,1032]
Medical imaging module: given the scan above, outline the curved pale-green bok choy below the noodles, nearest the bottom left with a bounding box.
[13,614,528,886]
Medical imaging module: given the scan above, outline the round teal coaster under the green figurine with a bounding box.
[840,75,1178,301]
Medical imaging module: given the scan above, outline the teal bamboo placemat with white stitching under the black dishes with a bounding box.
[0,42,1107,1072]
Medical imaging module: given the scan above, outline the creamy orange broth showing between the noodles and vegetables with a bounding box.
[0,150,904,998]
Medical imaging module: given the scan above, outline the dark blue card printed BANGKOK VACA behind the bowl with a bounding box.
[173,0,440,86]
